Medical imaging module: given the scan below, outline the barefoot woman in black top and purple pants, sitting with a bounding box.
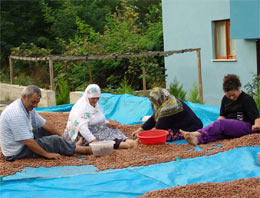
[180,74,260,146]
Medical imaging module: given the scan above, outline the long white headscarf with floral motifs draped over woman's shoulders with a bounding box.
[65,84,102,141]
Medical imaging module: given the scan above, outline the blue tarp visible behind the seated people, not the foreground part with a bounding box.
[35,93,219,126]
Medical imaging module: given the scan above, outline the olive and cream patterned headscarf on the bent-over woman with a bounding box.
[149,87,183,122]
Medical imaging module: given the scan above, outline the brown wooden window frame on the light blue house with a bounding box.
[213,19,236,60]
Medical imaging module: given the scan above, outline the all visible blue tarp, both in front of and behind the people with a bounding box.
[0,94,260,198]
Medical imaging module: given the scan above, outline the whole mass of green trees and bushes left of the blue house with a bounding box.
[0,0,165,90]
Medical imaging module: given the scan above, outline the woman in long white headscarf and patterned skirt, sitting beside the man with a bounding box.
[64,84,137,149]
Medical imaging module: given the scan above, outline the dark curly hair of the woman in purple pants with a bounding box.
[223,74,241,92]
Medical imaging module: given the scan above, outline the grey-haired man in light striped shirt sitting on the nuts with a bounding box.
[0,85,91,161]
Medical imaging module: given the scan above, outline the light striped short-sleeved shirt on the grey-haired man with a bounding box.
[0,99,46,157]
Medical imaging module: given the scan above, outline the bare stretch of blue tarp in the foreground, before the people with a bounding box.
[0,146,260,198]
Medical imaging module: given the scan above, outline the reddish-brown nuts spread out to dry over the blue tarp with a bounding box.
[0,112,260,198]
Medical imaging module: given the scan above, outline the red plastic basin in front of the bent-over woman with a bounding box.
[137,129,169,145]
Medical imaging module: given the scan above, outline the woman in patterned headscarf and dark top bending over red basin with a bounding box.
[132,87,202,141]
